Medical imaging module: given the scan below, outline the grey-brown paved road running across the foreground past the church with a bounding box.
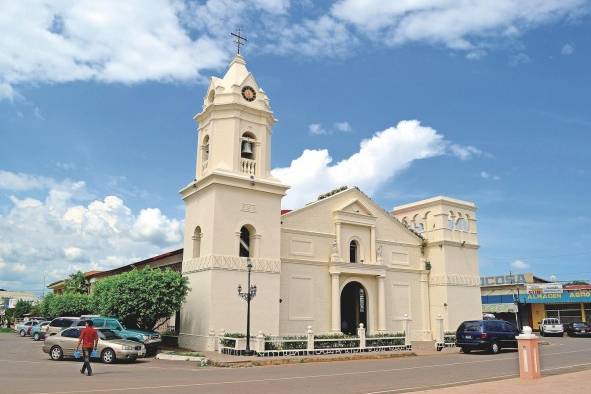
[0,334,591,394]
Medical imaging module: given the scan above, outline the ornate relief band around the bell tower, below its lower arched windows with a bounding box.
[183,255,281,274]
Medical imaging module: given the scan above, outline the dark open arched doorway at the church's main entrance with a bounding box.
[341,282,367,335]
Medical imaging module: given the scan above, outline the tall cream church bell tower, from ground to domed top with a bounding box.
[179,54,288,350]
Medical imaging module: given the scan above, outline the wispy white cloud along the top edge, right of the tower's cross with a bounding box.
[331,0,586,52]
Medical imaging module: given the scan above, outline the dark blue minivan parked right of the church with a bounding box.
[456,320,519,354]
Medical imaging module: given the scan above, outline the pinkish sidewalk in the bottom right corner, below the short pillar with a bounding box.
[414,370,591,394]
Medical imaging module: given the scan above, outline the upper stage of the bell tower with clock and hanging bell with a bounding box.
[194,55,276,179]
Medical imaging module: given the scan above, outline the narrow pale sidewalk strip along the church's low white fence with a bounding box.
[201,351,416,368]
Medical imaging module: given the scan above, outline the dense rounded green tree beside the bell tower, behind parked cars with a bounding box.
[93,268,189,330]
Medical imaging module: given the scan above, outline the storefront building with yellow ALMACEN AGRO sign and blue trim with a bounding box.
[480,272,591,330]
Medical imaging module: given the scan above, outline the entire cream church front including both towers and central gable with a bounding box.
[179,55,482,350]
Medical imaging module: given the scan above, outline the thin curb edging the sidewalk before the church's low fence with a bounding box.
[207,352,416,368]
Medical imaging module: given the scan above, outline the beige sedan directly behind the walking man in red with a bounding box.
[43,327,146,364]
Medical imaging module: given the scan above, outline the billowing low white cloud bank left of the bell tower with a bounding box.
[0,171,182,289]
